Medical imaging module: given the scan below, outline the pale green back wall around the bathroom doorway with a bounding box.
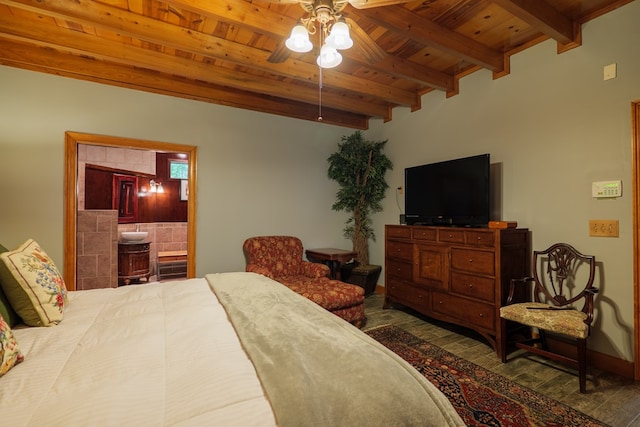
[0,67,352,276]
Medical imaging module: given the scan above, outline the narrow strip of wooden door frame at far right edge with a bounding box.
[631,101,640,380]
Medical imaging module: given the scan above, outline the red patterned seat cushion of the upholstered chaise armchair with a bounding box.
[276,276,364,311]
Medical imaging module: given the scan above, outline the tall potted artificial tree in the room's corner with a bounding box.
[328,131,393,295]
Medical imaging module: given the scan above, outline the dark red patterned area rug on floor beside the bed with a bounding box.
[366,325,605,427]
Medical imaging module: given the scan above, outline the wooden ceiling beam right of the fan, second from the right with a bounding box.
[349,6,504,72]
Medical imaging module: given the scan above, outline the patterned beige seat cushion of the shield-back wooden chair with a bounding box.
[500,302,589,338]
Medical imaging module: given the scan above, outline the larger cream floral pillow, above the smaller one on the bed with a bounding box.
[0,239,67,326]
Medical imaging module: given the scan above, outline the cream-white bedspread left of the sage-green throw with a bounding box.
[0,279,275,427]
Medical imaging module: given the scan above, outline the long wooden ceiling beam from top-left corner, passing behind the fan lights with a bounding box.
[0,0,418,106]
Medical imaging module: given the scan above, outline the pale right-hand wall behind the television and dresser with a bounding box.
[367,2,640,360]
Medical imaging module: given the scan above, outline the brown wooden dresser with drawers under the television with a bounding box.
[384,225,530,357]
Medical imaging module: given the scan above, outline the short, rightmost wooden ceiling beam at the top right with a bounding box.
[494,0,581,47]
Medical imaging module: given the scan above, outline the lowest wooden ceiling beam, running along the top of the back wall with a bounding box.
[0,40,369,130]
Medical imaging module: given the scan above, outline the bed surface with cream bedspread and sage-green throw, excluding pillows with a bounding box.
[0,272,463,427]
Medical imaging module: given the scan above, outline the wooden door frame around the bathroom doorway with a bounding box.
[63,132,198,290]
